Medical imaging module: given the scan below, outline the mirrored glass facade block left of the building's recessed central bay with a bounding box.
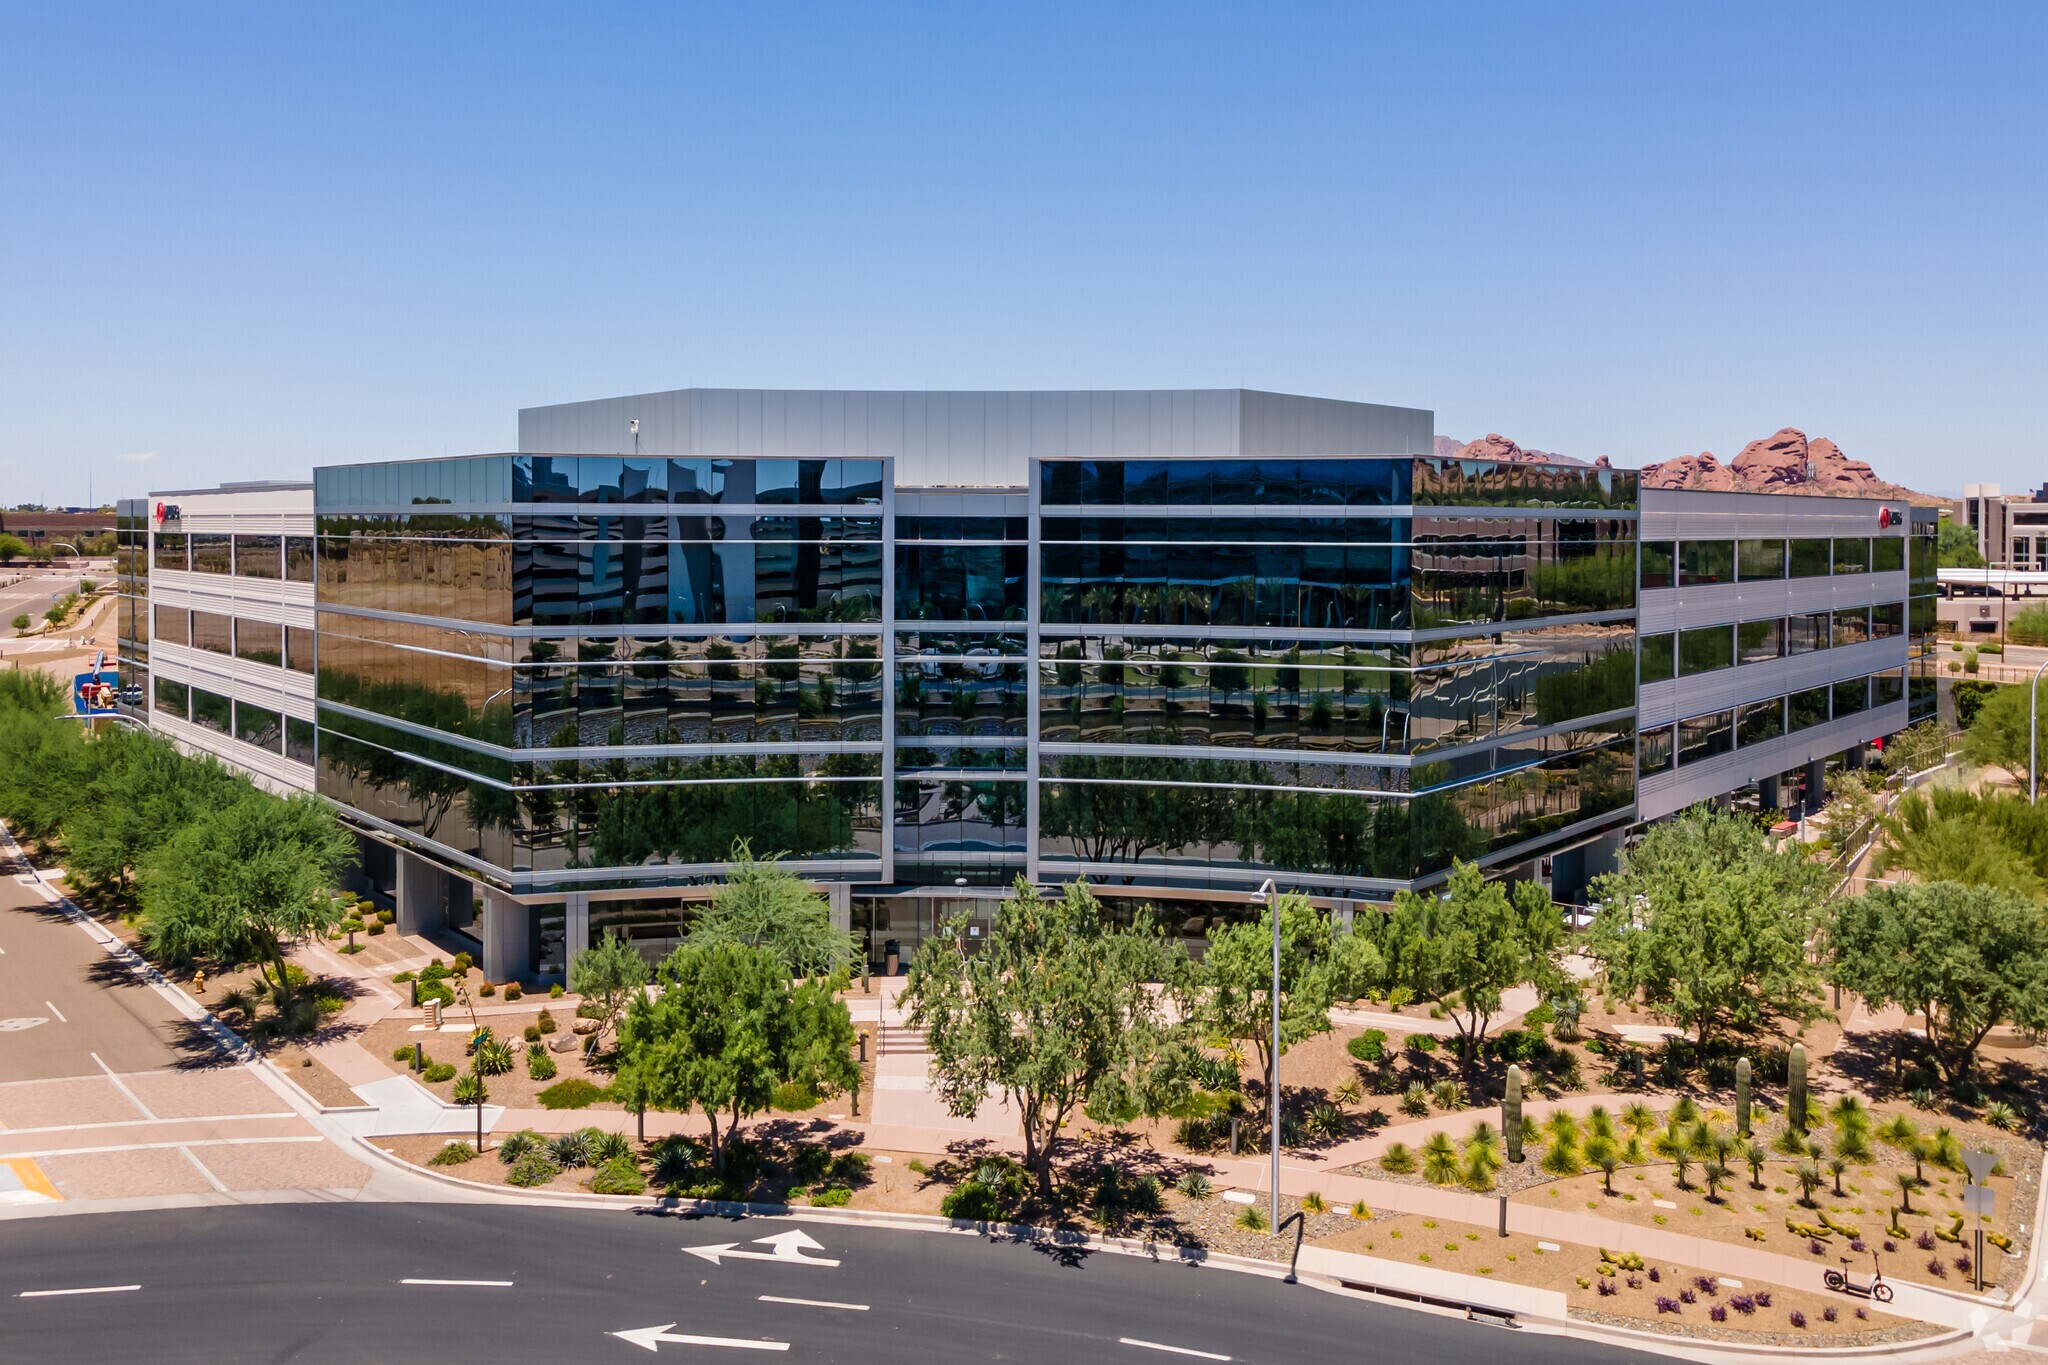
[315,456,887,888]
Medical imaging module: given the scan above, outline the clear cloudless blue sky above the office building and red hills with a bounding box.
[0,0,2048,503]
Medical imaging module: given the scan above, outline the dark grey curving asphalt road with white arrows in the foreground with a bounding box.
[0,1203,1647,1365]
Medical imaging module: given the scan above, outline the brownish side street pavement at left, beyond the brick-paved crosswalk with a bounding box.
[0,831,190,1080]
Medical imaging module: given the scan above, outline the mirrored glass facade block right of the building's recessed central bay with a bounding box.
[1032,458,1636,896]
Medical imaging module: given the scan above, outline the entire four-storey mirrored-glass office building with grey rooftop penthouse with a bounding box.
[136,391,1931,974]
